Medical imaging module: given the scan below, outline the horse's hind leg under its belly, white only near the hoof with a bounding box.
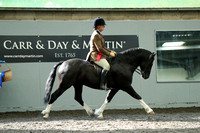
[74,85,94,116]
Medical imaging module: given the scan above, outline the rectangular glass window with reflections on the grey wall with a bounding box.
[156,31,200,82]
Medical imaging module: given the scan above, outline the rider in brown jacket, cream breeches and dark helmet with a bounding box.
[87,17,115,90]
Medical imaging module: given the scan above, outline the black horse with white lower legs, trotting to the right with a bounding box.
[42,48,156,119]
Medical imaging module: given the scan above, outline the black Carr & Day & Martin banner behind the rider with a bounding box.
[0,35,139,62]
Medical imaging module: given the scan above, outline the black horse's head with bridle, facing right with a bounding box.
[140,53,156,79]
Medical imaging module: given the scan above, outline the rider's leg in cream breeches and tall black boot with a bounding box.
[94,59,110,90]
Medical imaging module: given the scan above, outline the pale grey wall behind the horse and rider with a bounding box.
[0,20,200,112]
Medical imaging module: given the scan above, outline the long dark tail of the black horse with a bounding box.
[44,61,64,103]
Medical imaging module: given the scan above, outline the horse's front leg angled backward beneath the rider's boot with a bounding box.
[94,89,119,119]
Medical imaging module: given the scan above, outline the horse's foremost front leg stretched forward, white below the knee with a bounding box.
[123,86,154,114]
